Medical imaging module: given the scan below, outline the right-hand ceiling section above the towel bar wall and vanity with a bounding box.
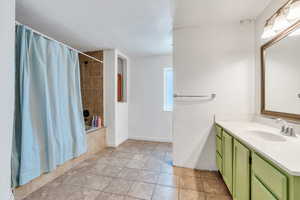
[174,0,271,27]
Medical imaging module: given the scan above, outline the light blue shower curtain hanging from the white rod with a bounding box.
[12,25,87,187]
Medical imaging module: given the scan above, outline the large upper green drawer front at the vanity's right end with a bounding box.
[252,153,287,200]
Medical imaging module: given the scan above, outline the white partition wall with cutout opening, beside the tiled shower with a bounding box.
[104,49,130,147]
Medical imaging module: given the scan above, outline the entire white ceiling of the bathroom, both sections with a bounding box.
[16,0,271,56]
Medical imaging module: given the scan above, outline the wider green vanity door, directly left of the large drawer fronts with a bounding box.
[233,140,251,200]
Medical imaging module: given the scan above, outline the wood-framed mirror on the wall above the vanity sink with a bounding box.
[261,23,300,120]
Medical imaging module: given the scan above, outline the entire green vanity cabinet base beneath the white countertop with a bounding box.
[216,125,300,200]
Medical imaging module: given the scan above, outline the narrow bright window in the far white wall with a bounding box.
[164,68,174,112]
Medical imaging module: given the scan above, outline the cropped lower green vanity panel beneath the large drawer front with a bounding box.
[251,176,277,200]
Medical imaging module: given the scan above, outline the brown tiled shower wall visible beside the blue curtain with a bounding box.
[79,51,104,125]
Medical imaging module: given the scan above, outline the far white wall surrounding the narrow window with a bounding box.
[129,56,173,142]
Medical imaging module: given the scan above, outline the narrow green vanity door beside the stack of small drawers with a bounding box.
[222,131,233,193]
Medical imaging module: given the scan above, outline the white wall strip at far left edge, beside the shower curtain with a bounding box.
[0,0,15,200]
